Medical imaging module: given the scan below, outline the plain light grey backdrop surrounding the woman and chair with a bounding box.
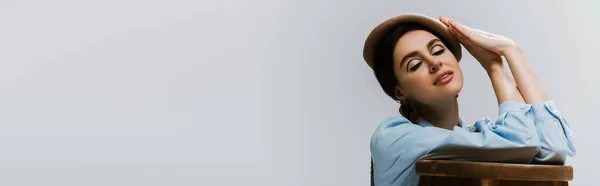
[0,0,600,186]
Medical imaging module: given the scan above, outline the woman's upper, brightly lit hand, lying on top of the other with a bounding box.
[440,16,519,56]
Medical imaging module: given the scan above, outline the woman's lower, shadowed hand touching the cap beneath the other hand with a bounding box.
[440,16,502,72]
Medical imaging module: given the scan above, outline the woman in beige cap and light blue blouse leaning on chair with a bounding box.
[363,14,575,186]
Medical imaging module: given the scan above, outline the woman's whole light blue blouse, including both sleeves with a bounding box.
[371,101,575,186]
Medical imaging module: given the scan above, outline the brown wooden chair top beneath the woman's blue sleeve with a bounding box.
[416,160,573,186]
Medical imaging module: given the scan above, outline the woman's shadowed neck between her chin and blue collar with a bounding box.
[417,98,458,130]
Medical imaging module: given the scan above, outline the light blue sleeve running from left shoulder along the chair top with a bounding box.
[371,103,540,185]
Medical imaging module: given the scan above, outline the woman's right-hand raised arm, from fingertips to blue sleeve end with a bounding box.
[446,16,575,164]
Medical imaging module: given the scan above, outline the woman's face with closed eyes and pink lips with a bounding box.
[394,30,463,105]
